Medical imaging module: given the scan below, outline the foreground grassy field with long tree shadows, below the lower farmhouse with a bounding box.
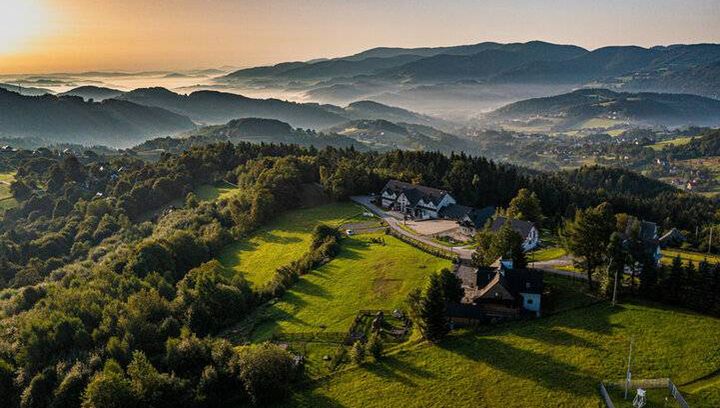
[285,278,720,408]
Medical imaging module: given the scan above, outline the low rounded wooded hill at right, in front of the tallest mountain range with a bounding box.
[487,89,720,130]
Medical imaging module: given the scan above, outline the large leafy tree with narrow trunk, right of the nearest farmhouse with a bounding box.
[562,203,615,289]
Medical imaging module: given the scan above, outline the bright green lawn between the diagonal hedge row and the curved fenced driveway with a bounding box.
[251,233,452,341]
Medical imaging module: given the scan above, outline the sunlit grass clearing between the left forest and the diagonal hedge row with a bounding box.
[219,203,362,285]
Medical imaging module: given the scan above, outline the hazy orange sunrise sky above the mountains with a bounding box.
[0,0,720,73]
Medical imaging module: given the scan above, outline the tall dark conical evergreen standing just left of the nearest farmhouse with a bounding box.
[418,273,448,342]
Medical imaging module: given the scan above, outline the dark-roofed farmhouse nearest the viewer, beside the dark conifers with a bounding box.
[447,260,543,325]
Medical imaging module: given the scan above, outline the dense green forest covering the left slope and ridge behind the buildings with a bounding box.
[0,142,717,407]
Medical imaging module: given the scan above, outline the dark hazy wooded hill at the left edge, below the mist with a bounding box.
[0,90,195,146]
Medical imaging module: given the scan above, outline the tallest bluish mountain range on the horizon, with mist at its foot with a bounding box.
[219,41,720,112]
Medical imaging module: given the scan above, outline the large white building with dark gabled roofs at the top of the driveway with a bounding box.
[380,180,456,220]
